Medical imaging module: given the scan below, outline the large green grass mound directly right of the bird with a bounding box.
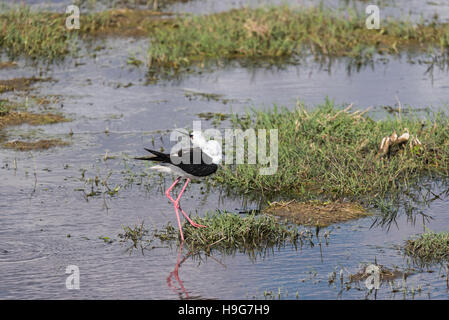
[215,100,449,201]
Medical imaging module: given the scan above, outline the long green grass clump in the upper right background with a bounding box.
[149,6,449,69]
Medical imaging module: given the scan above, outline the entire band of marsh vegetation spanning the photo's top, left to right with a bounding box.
[0,1,449,70]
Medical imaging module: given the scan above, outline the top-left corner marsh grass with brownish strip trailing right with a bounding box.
[0,6,161,61]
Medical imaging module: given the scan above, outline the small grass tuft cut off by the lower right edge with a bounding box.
[404,232,449,264]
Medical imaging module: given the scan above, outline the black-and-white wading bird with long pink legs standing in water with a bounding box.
[134,131,222,242]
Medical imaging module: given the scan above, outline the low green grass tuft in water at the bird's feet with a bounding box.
[156,212,309,253]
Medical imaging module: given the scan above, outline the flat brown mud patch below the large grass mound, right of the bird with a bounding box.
[264,200,370,227]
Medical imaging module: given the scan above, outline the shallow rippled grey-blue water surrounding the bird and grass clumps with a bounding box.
[0,1,449,299]
